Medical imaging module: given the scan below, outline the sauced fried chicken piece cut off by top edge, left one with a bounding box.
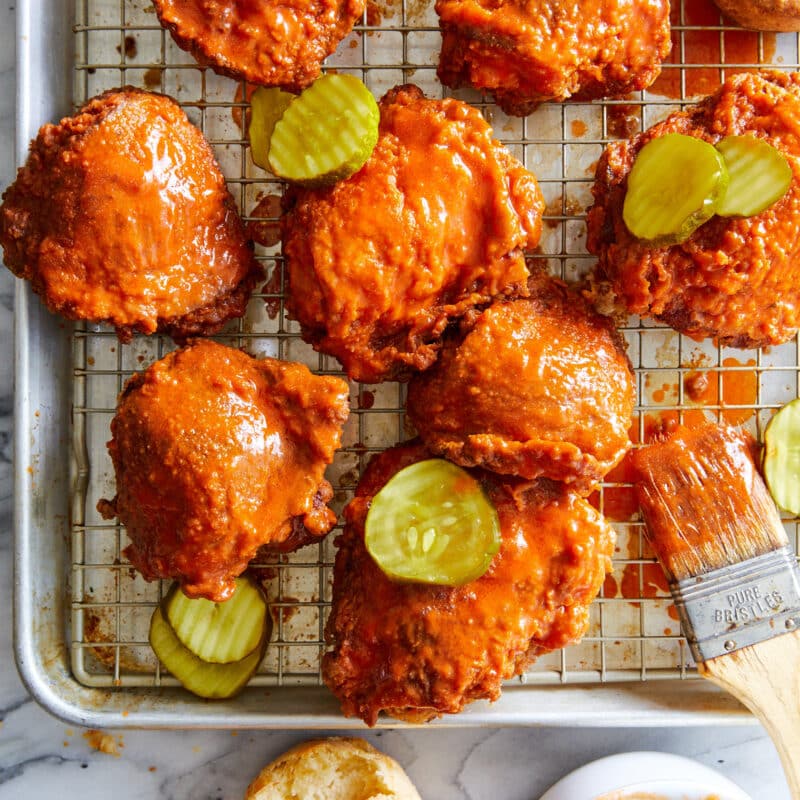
[153,0,365,92]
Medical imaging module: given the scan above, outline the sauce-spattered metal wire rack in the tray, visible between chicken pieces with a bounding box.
[70,0,800,687]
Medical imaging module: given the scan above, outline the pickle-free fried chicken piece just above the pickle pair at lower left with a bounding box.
[98,340,349,601]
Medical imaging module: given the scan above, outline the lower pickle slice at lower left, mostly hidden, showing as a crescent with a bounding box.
[149,607,268,700]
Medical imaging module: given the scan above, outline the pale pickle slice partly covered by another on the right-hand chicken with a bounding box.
[717,136,792,217]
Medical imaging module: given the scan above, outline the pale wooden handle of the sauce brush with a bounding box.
[698,630,800,800]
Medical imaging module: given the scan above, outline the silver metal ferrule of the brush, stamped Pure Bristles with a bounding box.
[670,545,800,662]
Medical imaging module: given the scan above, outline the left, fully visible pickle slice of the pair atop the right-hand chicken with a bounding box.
[622,133,728,245]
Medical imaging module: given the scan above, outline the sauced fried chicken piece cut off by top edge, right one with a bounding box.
[436,0,670,116]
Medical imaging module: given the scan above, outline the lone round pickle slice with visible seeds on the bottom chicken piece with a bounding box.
[365,458,500,586]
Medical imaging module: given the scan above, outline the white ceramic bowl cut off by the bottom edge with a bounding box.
[541,752,752,800]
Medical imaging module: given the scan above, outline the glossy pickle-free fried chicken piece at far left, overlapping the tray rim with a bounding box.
[0,88,262,341]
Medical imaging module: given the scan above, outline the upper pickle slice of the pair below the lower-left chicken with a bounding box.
[163,576,272,664]
